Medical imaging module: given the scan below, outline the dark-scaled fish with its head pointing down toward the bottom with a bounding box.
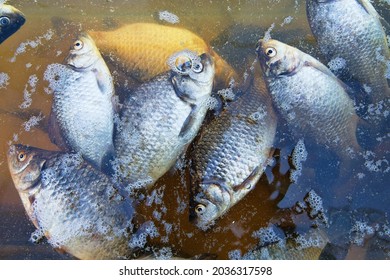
[190,65,277,230]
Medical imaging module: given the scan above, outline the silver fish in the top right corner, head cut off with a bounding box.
[306,0,390,111]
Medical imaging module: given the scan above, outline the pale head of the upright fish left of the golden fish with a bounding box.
[64,33,101,71]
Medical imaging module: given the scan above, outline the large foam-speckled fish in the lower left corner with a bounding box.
[7,144,135,259]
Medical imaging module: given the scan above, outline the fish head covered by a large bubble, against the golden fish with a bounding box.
[167,50,215,102]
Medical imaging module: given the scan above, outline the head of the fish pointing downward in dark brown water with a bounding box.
[190,183,232,230]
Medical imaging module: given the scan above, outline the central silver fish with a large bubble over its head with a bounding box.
[113,50,215,189]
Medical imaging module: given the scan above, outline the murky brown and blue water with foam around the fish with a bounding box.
[0,0,390,259]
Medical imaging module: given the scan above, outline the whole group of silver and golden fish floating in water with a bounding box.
[0,0,390,259]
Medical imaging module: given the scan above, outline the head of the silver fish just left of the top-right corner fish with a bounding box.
[256,39,301,77]
